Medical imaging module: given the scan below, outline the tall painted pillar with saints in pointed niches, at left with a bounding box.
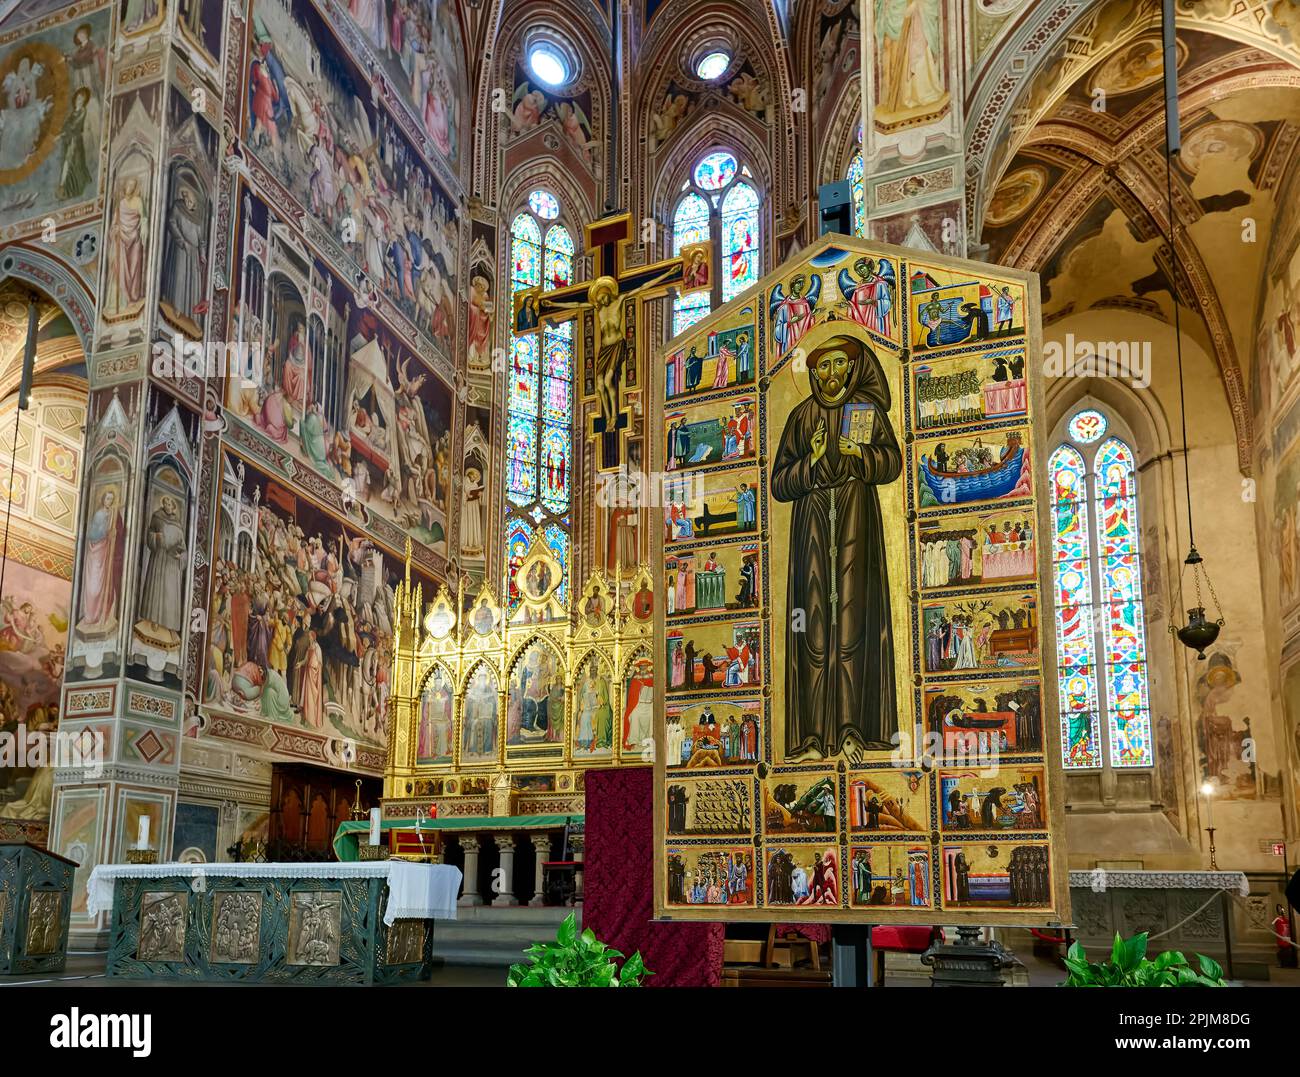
[41,5,228,947]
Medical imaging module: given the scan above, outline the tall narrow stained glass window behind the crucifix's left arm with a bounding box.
[506,199,575,607]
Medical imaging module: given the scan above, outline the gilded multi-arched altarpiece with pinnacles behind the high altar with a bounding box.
[385,533,654,818]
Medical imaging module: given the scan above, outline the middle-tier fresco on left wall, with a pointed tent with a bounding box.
[228,188,457,553]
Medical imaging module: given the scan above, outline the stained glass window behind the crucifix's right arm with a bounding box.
[672,151,763,336]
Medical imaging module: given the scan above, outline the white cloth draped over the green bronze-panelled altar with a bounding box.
[86,860,460,926]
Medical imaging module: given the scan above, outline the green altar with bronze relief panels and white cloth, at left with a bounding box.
[86,860,460,983]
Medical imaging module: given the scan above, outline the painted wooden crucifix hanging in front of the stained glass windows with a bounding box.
[514,213,712,471]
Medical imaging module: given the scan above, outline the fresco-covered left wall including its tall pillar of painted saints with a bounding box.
[0,0,480,884]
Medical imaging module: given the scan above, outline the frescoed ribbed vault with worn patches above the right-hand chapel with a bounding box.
[980,30,1300,468]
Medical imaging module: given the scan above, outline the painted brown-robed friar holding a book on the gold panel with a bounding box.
[772,336,902,760]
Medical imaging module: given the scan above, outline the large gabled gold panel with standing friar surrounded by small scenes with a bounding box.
[647,235,1069,925]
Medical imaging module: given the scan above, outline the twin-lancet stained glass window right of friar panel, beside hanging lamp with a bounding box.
[1048,410,1154,770]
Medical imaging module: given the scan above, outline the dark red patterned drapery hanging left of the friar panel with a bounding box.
[582,767,723,987]
